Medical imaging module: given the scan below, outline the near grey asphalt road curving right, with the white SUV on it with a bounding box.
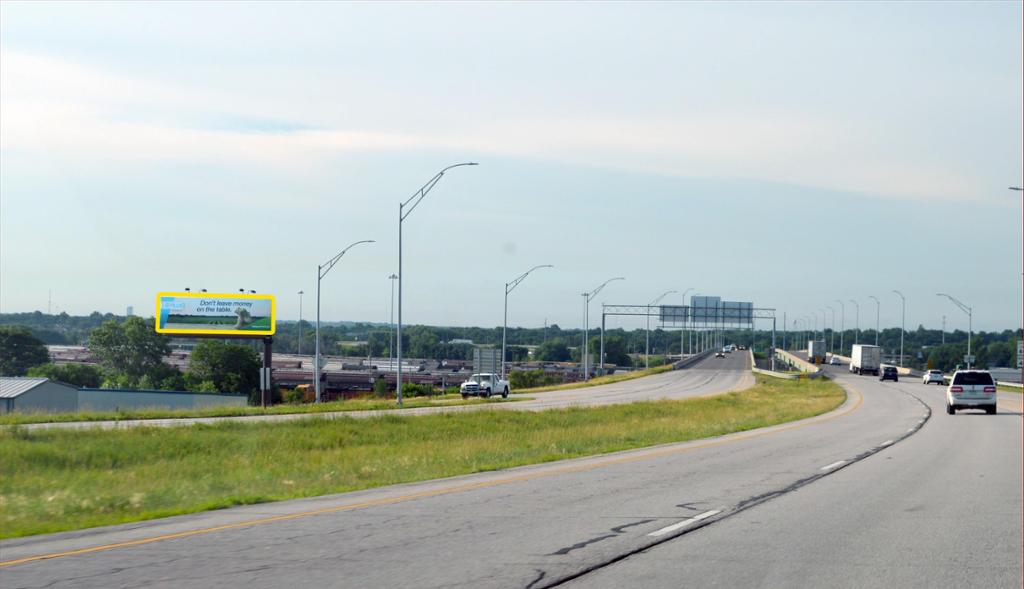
[0,359,1022,589]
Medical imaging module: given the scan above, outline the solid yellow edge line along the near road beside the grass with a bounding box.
[0,389,864,567]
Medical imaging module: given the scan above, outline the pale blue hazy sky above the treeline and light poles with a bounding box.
[0,1,1022,330]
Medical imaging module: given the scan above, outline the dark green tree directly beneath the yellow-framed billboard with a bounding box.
[188,339,260,397]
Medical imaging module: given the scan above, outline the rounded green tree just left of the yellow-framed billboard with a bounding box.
[89,317,170,384]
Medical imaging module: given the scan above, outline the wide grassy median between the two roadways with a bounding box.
[0,376,845,538]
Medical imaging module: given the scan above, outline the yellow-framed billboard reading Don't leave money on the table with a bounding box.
[157,292,276,337]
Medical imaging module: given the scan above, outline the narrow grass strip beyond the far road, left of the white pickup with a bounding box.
[0,394,523,425]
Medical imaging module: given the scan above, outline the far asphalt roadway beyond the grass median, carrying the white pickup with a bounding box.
[22,353,754,430]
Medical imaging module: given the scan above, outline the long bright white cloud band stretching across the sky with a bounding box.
[0,50,999,204]
